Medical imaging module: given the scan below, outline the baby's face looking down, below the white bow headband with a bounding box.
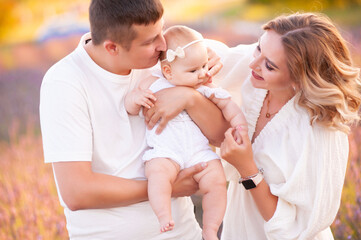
[168,42,208,88]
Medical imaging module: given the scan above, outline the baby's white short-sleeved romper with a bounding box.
[143,73,230,169]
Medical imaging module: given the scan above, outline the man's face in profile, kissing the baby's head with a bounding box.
[120,18,166,69]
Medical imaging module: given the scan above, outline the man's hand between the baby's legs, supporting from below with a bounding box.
[172,163,208,197]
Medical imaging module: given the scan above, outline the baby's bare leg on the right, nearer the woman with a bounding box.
[194,159,227,240]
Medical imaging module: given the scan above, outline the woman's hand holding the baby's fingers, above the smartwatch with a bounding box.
[221,127,258,176]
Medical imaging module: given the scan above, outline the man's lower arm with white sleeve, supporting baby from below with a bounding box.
[40,76,203,210]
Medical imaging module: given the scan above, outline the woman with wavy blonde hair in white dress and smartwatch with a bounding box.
[221,13,361,240]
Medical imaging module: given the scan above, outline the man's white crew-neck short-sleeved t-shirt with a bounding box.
[40,35,201,240]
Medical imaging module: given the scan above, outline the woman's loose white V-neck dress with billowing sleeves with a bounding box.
[210,40,349,240]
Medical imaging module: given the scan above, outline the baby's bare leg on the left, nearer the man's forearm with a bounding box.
[145,158,179,232]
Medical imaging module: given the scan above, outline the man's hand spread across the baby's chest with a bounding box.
[143,87,196,134]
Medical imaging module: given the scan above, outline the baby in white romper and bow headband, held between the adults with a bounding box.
[125,26,246,240]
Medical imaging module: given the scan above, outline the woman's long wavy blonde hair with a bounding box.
[263,13,361,133]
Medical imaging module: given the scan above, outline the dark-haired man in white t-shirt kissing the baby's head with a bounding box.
[40,0,227,240]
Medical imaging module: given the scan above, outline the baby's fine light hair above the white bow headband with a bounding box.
[159,25,203,61]
